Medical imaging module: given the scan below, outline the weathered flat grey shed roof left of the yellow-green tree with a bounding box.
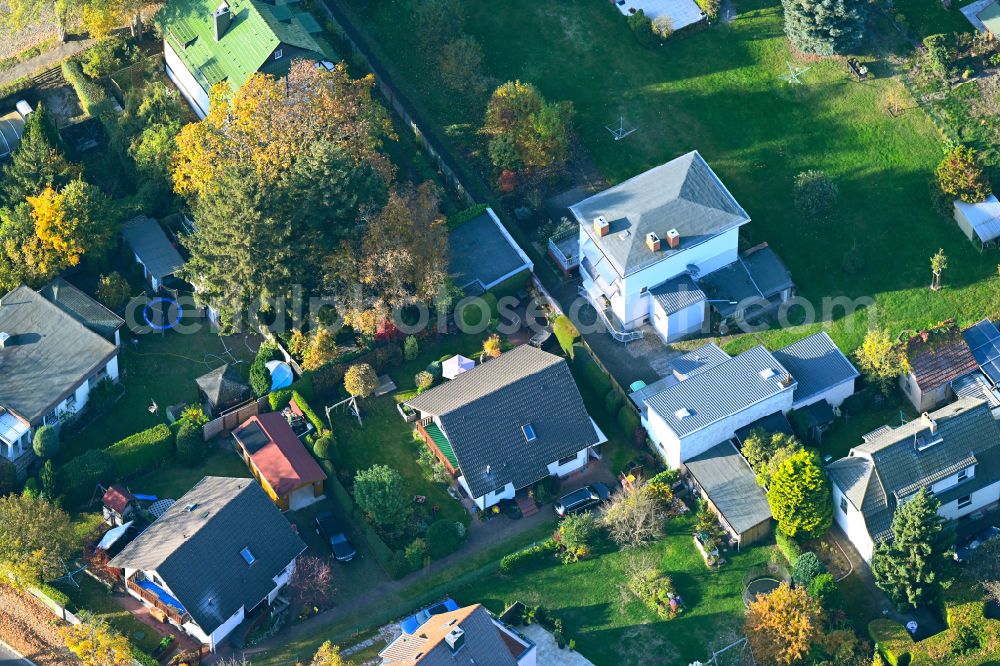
[684,441,771,534]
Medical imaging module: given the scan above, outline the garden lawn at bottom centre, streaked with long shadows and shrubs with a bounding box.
[453,514,773,666]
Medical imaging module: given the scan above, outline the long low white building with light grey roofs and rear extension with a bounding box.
[630,332,858,469]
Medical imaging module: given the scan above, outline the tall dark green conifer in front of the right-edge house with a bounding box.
[872,488,948,607]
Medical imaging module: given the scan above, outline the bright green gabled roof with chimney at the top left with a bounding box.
[156,0,323,90]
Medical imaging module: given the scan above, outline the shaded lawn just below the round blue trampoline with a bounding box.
[59,324,253,461]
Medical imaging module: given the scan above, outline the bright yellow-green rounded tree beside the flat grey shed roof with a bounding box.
[767,450,833,539]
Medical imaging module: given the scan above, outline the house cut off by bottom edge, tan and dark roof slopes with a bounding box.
[379,604,538,666]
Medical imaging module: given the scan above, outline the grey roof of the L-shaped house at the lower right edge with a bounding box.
[827,398,1000,540]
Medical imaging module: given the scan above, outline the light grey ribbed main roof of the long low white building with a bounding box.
[646,346,795,437]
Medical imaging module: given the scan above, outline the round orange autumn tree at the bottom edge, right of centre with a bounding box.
[744,583,823,666]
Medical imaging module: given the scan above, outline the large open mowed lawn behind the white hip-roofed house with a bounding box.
[333,0,1000,349]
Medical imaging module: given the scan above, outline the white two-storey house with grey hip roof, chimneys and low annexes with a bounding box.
[569,151,794,342]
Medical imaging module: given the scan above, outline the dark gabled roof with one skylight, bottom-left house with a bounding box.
[110,476,306,634]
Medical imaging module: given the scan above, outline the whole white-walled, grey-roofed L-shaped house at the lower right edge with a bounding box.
[826,398,1000,561]
